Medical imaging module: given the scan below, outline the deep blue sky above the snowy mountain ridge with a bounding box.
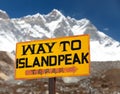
[0,0,120,42]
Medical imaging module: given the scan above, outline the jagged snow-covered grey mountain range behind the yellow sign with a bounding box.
[0,9,120,61]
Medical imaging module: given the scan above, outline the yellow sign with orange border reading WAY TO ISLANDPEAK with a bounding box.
[15,35,90,79]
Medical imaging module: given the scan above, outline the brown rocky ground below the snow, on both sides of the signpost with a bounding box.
[0,51,120,94]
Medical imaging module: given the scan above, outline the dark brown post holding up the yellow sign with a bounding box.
[49,77,56,94]
